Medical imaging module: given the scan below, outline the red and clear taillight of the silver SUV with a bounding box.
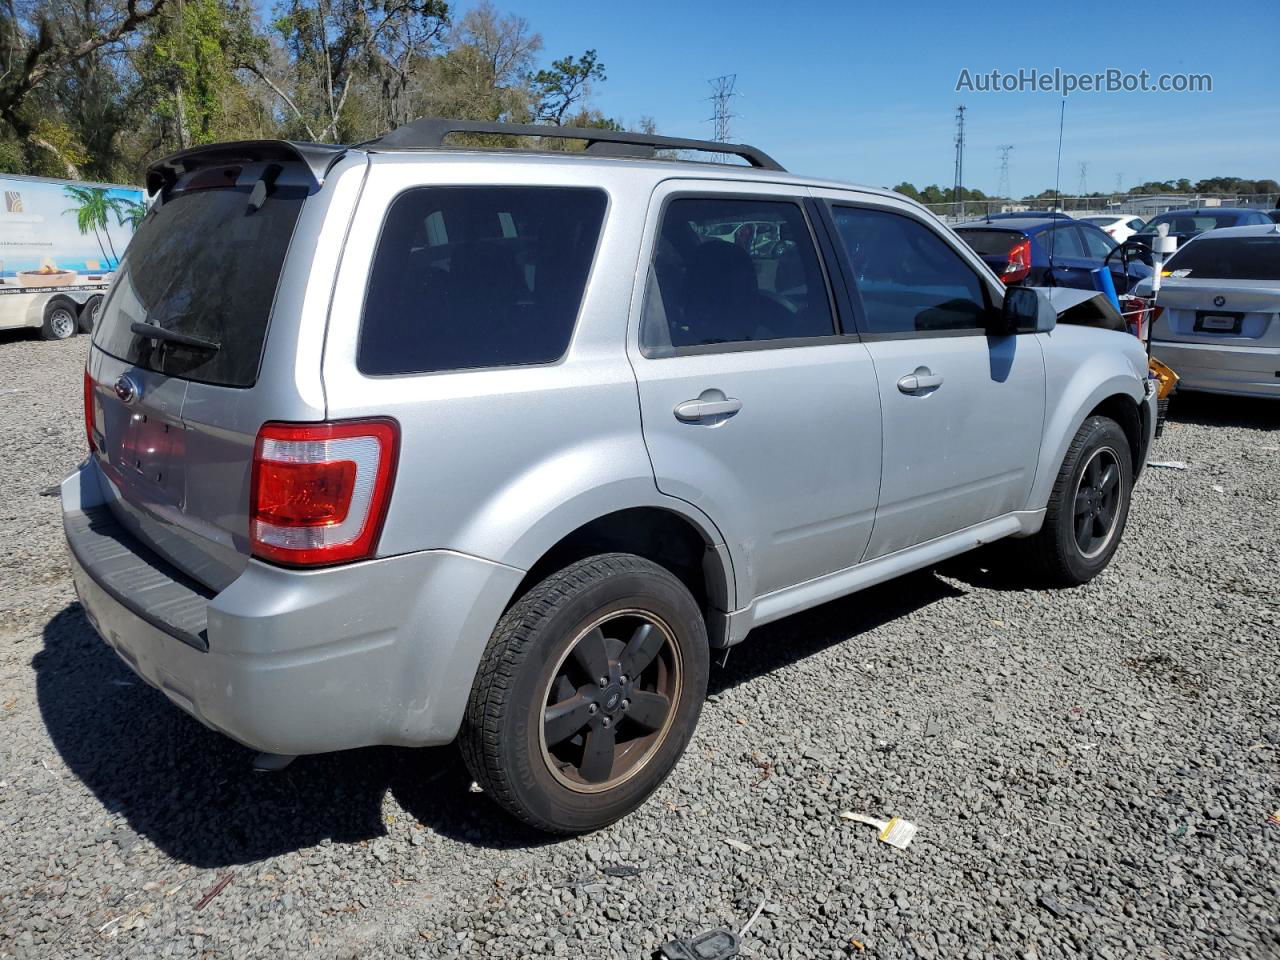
[250,420,399,567]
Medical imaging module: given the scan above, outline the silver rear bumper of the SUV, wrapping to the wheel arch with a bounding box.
[61,463,524,754]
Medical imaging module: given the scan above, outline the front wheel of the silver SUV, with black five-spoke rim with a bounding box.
[1025,416,1133,586]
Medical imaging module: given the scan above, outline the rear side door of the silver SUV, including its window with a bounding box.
[628,180,881,602]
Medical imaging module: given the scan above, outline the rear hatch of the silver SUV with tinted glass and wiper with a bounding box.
[87,151,343,590]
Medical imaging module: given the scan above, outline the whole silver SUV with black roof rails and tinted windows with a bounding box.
[61,120,1156,832]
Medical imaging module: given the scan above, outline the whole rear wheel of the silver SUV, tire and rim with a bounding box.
[460,553,710,833]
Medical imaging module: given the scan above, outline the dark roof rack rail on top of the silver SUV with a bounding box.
[358,116,785,170]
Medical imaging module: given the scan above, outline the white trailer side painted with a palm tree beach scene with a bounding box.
[0,177,146,287]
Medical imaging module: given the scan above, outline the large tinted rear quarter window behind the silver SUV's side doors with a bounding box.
[356,187,605,375]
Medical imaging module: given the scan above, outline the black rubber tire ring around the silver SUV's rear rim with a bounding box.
[499,570,710,832]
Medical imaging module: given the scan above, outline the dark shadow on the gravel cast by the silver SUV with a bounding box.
[42,572,961,869]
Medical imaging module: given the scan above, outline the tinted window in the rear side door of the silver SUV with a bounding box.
[640,197,835,356]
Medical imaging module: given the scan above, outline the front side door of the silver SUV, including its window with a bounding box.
[823,192,1044,559]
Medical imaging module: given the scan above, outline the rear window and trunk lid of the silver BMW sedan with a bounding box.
[1152,234,1280,348]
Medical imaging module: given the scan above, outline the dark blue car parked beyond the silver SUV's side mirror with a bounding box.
[956,216,1151,293]
